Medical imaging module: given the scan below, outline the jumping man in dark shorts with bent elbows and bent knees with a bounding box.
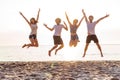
[44,18,68,56]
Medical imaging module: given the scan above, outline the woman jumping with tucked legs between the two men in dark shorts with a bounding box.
[65,13,84,47]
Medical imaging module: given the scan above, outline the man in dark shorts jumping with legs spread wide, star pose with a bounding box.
[82,10,109,57]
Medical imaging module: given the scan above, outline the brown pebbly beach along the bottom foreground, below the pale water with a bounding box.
[0,61,120,80]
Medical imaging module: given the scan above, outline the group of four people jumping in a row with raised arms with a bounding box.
[20,9,109,57]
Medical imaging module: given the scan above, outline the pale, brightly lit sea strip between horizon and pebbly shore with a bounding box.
[0,44,120,61]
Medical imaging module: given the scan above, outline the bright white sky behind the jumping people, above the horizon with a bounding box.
[0,0,120,45]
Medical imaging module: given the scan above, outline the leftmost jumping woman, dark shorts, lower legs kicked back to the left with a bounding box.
[20,9,40,48]
